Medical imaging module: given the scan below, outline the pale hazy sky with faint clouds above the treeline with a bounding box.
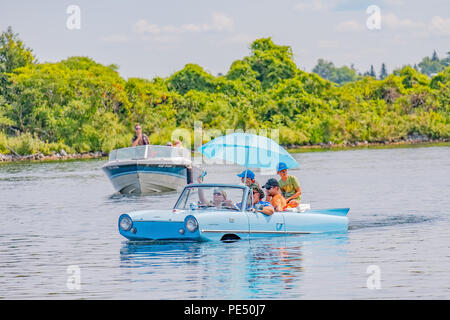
[0,0,450,79]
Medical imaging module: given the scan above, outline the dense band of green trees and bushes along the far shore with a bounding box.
[0,27,450,162]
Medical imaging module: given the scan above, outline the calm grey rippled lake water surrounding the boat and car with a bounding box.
[0,147,450,299]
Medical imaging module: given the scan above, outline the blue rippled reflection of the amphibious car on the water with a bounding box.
[115,234,347,299]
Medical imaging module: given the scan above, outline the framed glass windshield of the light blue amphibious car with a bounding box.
[175,186,244,211]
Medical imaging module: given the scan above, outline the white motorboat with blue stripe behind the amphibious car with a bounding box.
[102,145,199,194]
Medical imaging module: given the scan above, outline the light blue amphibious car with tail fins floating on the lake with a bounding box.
[118,184,349,241]
